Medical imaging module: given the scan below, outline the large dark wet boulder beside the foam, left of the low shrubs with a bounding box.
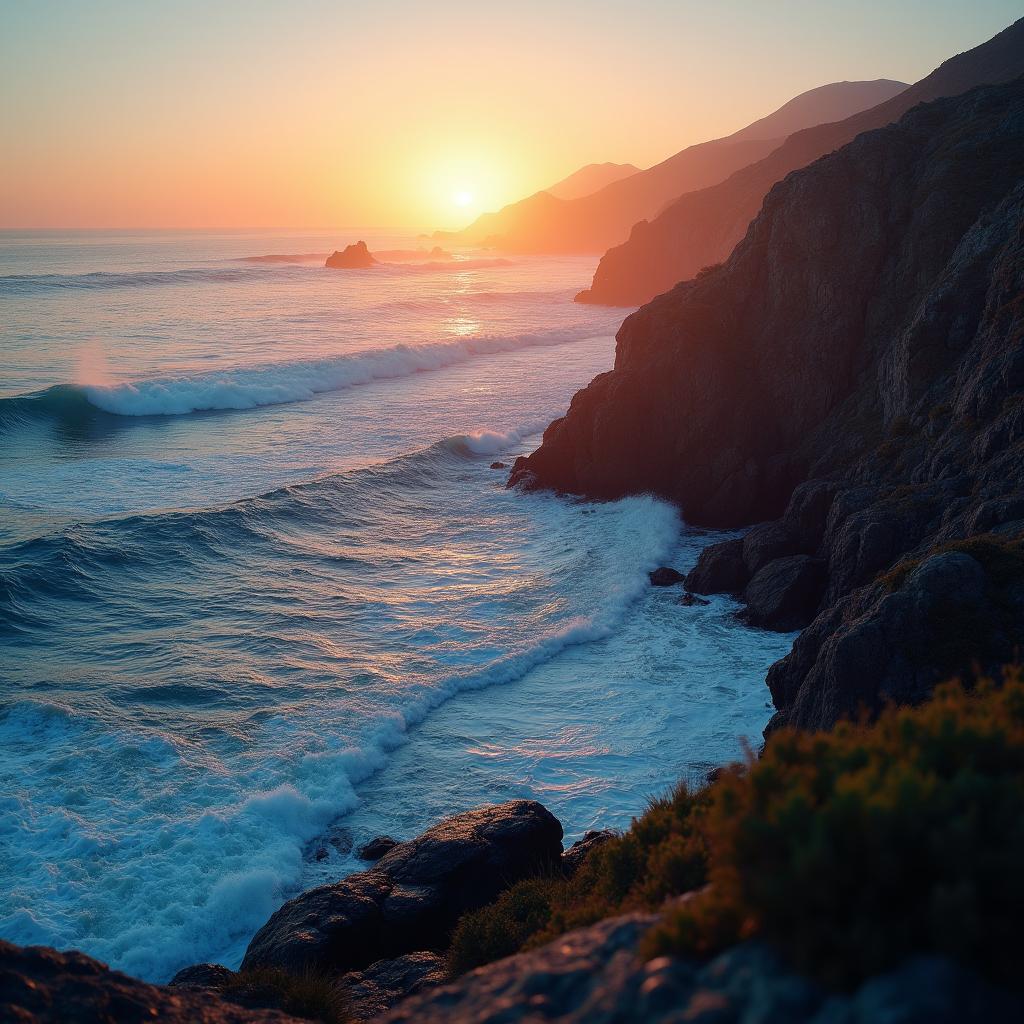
[242,800,562,972]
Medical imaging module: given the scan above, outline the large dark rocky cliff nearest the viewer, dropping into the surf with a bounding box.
[511,80,1024,726]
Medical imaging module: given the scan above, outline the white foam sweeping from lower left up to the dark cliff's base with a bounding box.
[0,497,679,981]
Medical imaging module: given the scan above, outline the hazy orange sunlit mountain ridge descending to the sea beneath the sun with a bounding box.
[444,81,906,252]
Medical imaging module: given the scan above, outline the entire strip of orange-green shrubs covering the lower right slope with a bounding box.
[449,669,1024,986]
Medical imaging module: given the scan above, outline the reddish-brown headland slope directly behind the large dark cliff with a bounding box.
[578,19,1024,305]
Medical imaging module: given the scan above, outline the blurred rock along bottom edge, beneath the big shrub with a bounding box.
[381,914,1024,1024]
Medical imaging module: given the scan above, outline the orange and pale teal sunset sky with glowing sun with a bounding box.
[0,0,1021,228]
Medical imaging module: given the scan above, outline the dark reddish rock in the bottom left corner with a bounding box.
[0,940,298,1024]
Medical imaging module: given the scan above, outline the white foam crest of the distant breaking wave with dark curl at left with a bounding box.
[82,327,606,416]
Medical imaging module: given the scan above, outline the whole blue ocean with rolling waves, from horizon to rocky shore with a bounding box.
[0,231,792,981]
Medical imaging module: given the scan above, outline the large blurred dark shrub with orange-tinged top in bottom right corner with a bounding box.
[646,673,1024,984]
